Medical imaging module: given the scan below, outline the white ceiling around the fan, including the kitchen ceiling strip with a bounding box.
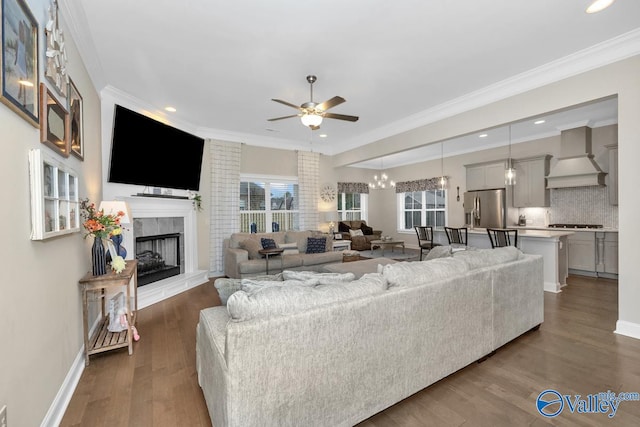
[59,0,640,167]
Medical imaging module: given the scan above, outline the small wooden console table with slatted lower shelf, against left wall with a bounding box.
[79,260,138,366]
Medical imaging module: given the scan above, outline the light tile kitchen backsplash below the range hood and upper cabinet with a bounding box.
[518,186,618,229]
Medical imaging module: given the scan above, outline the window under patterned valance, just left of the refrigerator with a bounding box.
[398,190,447,231]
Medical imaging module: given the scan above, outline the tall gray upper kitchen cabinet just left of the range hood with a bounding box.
[513,155,551,208]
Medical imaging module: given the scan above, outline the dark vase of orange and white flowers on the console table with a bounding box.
[80,199,126,276]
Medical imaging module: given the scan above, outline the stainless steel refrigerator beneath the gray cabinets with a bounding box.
[464,188,507,228]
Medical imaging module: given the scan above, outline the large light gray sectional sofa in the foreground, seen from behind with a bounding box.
[196,247,543,427]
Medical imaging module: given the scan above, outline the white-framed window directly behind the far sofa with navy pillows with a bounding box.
[240,177,300,233]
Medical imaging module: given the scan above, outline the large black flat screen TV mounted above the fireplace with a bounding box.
[109,105,204,191]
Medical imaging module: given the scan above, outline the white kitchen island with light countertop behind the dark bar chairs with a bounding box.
[433,228,574,293]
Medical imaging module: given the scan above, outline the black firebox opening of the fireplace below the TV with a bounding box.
[136,233,181,286]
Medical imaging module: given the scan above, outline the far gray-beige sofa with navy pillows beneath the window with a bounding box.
[223,231,342,279]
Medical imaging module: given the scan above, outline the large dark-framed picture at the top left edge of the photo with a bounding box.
[0,0,40,127]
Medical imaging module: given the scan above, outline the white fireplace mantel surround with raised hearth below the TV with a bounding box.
[116,196,208,308]
